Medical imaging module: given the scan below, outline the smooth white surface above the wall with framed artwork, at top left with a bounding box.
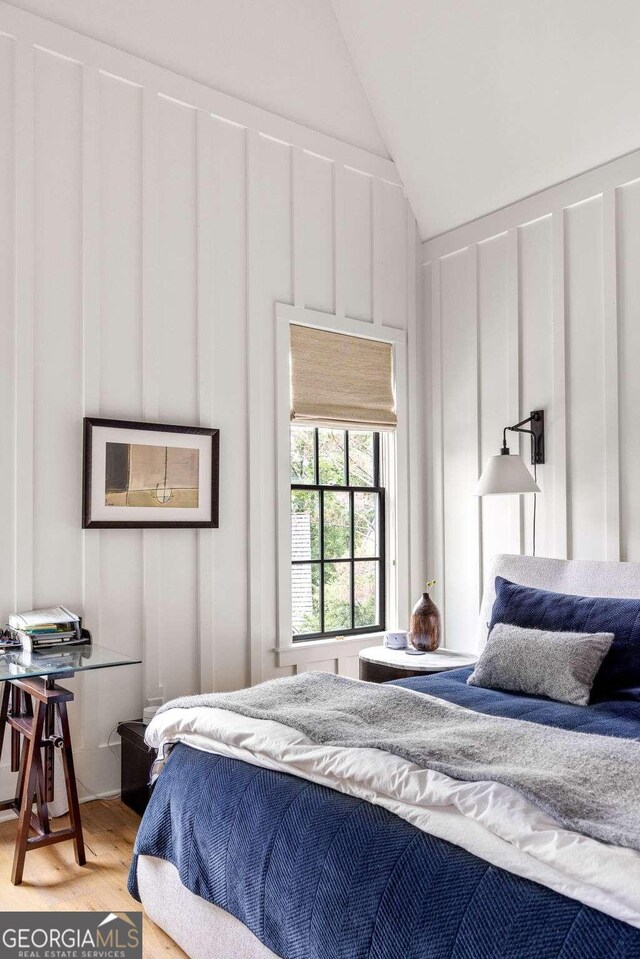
[11,0,388,157]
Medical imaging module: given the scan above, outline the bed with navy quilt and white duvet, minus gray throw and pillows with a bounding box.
[130,556,640,959]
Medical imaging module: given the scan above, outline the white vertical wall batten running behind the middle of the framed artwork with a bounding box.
[142,89,163,701]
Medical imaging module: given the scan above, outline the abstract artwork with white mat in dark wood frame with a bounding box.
[82,416,220,529]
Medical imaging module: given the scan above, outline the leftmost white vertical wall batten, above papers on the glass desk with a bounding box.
[14,43,35,609]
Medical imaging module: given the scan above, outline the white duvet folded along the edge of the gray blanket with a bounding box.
[146,706,640,928]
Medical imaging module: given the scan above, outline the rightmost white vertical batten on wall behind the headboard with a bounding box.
[602,189,620,561]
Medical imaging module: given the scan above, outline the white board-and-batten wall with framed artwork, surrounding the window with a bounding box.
[0,3,424,793]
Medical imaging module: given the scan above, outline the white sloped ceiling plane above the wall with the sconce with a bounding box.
[331,0,640,238]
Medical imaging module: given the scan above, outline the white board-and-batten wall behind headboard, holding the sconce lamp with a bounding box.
[422,152,640,648]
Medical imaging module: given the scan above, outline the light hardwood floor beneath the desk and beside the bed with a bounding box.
[0,799,185,959]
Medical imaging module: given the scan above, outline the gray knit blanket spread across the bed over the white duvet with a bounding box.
[159,672,640,851]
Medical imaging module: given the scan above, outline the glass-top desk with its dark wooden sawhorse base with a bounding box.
[0,643,141,886]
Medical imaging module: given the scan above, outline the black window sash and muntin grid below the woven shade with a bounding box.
[291,426,387,644]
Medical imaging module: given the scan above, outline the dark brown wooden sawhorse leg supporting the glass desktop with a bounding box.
[0,677,87,886]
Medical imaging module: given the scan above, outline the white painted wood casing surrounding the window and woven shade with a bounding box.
[276,303,410,660]
